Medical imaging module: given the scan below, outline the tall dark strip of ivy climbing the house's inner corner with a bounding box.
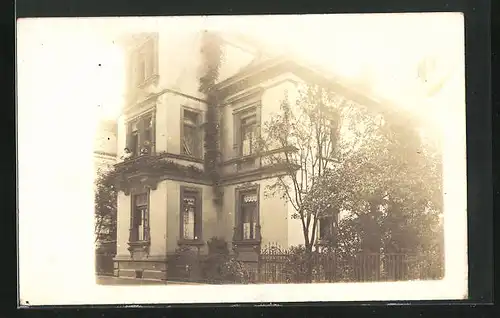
[199,30,223,202]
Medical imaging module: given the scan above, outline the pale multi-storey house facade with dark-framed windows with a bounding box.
[114,32,386,279]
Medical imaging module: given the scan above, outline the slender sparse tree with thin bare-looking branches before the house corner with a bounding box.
[258,85,372,279]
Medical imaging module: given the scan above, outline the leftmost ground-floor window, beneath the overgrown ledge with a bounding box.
[130,193,149,242]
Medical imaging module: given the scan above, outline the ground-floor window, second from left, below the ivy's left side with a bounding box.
[180,188,202,241]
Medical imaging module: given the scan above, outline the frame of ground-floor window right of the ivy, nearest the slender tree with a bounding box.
[235,185,261,243]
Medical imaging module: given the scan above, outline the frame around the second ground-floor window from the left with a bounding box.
[178,186,203,245]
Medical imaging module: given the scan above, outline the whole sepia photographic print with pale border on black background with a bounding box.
[17,13,467,304]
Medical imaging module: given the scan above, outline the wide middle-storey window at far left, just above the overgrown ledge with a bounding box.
[127,113,154,156]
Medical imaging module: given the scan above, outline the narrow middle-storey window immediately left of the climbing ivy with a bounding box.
[181,109,201,158]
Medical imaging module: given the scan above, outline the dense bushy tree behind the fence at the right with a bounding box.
[322,110,443,277]
